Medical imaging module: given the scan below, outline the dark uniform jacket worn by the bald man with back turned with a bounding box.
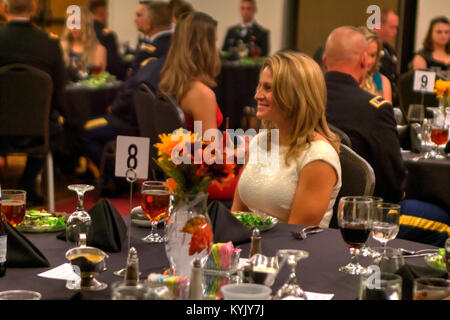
[325,71,406,203]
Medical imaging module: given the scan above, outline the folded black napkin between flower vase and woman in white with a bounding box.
[208,201,252,246]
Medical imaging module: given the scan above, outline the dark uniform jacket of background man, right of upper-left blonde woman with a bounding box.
[94,20,127,80]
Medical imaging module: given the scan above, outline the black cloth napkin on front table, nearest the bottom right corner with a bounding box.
[395,264,447,300]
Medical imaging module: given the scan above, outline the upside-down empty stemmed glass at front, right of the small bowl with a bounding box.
[274,249,309,300]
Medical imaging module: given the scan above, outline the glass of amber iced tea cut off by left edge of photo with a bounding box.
[2,190,27,227]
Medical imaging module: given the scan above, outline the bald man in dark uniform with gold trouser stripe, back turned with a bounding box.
[323,27,450,245]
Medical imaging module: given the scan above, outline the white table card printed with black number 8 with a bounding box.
[115,136,150,179]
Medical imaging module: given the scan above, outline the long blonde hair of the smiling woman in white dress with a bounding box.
[261,51,340,164]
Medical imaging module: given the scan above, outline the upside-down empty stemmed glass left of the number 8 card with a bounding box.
[66,184,94,247]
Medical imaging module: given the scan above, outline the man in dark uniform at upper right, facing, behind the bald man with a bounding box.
[374,9,400,105]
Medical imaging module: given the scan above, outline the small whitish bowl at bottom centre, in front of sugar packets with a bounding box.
[222,283,272,300]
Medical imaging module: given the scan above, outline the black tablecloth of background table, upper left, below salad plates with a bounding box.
[64,81,123,127]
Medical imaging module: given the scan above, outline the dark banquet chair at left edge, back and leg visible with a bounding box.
[0,64,55,211]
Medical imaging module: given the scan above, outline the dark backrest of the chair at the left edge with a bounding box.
[0,64,53,148]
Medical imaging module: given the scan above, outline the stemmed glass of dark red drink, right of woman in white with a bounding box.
[338,196,373,275]
